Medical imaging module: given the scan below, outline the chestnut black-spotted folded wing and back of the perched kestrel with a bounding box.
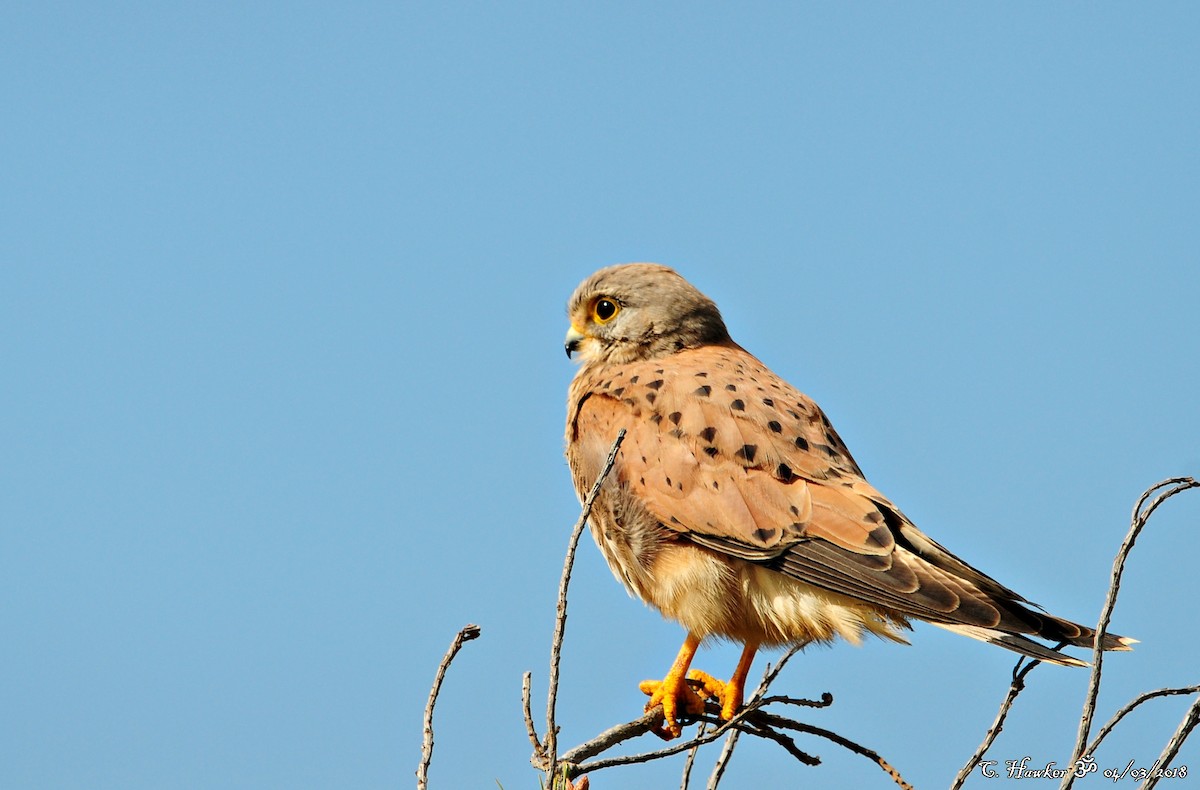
[569,345,1128,660]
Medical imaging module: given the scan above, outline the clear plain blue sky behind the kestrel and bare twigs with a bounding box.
[0,2,1200,790]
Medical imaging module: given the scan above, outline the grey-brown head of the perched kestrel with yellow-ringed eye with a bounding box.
[564,263,730,364]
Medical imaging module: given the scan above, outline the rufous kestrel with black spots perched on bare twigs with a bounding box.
[564,263,1136,738]
